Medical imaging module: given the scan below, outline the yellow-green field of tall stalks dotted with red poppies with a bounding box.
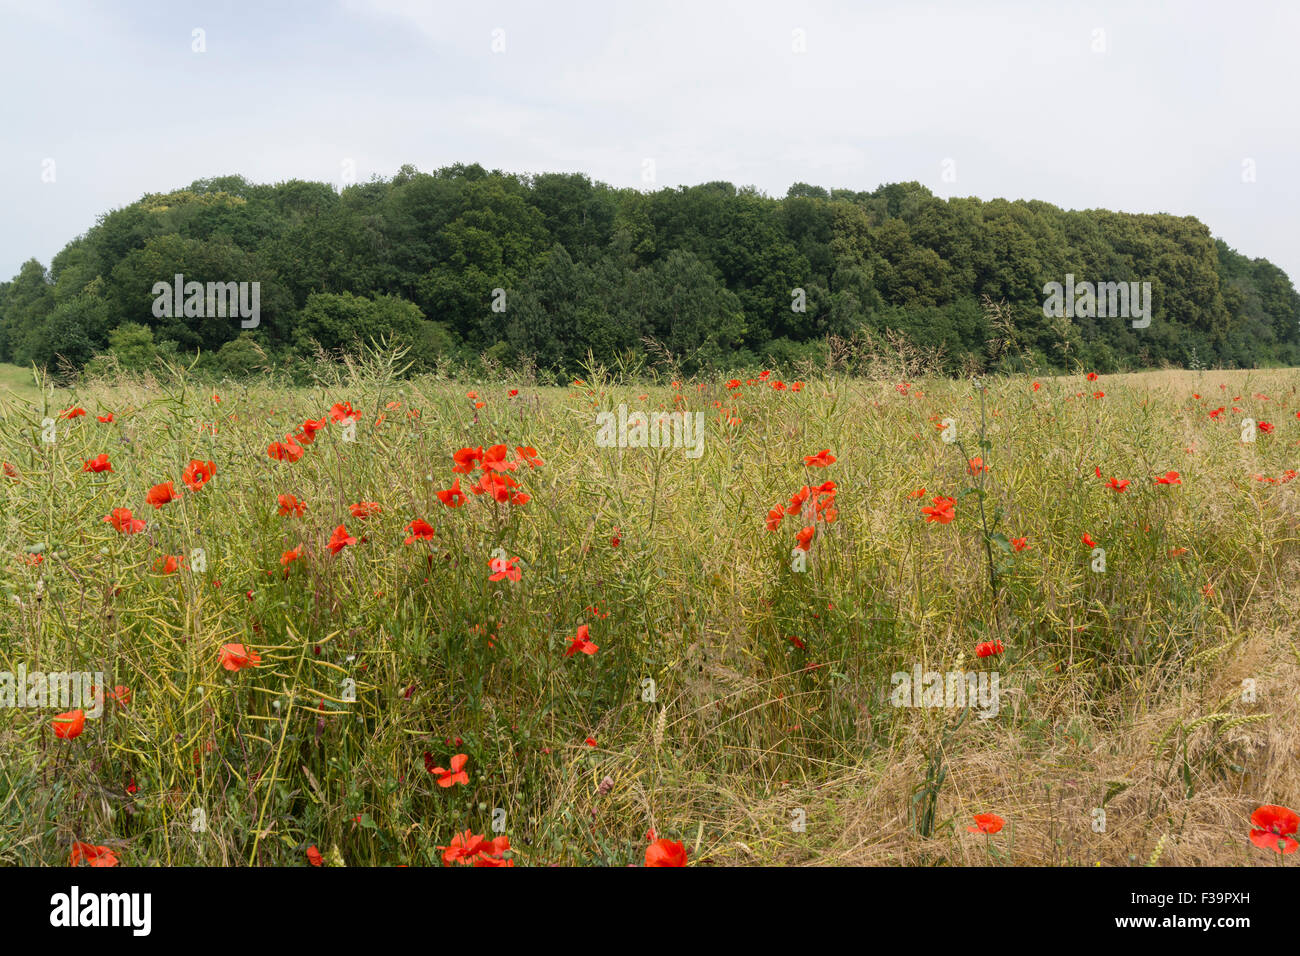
[0,363,1300,866]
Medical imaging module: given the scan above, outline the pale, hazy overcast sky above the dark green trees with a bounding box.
[0,0,1300,281]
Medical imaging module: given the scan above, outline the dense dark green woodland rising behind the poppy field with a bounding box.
[0,165,1300,381]
